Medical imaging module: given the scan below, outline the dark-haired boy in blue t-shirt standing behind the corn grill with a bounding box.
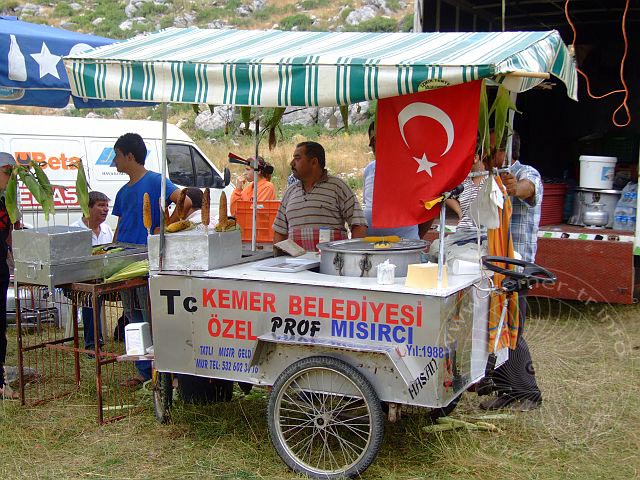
[113,133,191,386]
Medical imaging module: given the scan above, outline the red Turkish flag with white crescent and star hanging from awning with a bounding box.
[372,80,482,227]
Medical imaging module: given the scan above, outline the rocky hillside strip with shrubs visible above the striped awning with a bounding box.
[0,0,413,38]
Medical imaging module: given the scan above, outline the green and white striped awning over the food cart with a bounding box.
[64,28,577,107]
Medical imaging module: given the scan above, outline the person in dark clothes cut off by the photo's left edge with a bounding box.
[0,152,19,400]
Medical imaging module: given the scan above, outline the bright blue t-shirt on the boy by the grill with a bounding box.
[113,172,178,245]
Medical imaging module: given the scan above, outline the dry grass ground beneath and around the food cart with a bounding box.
[0,301,640,480]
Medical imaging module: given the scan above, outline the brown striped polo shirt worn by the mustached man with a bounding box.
[273,170,367,235]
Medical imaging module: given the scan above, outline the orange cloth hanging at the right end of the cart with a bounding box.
[487,176,520,352]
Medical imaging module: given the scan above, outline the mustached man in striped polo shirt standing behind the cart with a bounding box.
[273,142,367,250]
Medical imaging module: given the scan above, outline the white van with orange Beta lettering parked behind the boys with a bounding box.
[0,114,233,227]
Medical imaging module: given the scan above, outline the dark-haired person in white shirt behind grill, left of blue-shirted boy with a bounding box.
[70,191,113,350]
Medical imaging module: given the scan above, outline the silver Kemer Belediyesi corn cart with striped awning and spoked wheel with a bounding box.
[65,28,576,478]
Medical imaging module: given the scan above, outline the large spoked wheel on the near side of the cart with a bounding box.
[267,357,384,479]
